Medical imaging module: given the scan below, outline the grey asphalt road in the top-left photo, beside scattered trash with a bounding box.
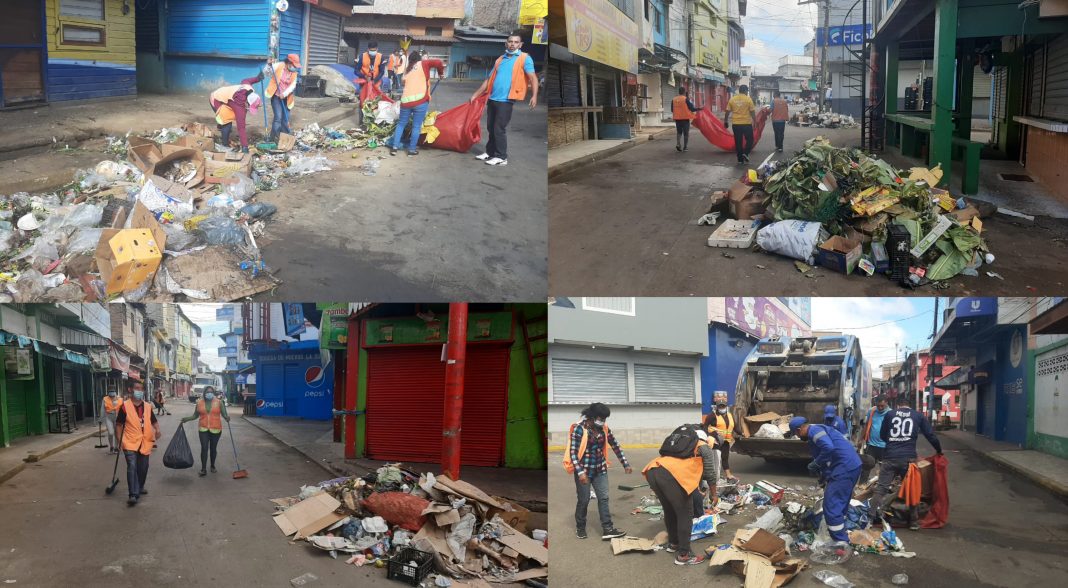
[257,80,548,302]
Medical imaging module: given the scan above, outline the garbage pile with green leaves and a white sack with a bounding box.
[708,137,1000,288]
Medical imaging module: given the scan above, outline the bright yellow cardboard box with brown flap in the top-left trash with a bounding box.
[94,202,167,296]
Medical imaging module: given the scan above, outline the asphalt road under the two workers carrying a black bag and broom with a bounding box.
[0,407,396,588]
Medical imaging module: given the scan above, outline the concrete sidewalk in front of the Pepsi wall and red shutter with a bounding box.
[242,416,549,511]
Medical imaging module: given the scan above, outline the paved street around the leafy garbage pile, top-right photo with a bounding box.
[549,116,1068,296]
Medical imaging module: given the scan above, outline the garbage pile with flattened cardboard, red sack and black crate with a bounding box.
[271,464,549,587]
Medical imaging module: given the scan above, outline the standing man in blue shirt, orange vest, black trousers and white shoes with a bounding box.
[471,34,538,165]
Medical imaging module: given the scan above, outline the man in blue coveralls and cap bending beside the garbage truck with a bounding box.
[790,416,861,541]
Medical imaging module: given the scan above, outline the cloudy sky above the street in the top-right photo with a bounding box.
[741,0,816,74]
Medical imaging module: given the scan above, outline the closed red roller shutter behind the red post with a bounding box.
[367,345,508,466]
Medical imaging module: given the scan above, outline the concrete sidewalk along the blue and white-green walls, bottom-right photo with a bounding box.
[938,429,1068,500]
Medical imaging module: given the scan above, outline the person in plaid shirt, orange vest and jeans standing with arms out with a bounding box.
[564,402,633,541]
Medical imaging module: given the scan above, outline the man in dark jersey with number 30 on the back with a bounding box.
[869,396,942,530]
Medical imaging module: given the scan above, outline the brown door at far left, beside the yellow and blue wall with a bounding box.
[0,0,45,108]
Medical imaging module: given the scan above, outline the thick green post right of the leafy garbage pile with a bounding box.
[928,0,957,186]
